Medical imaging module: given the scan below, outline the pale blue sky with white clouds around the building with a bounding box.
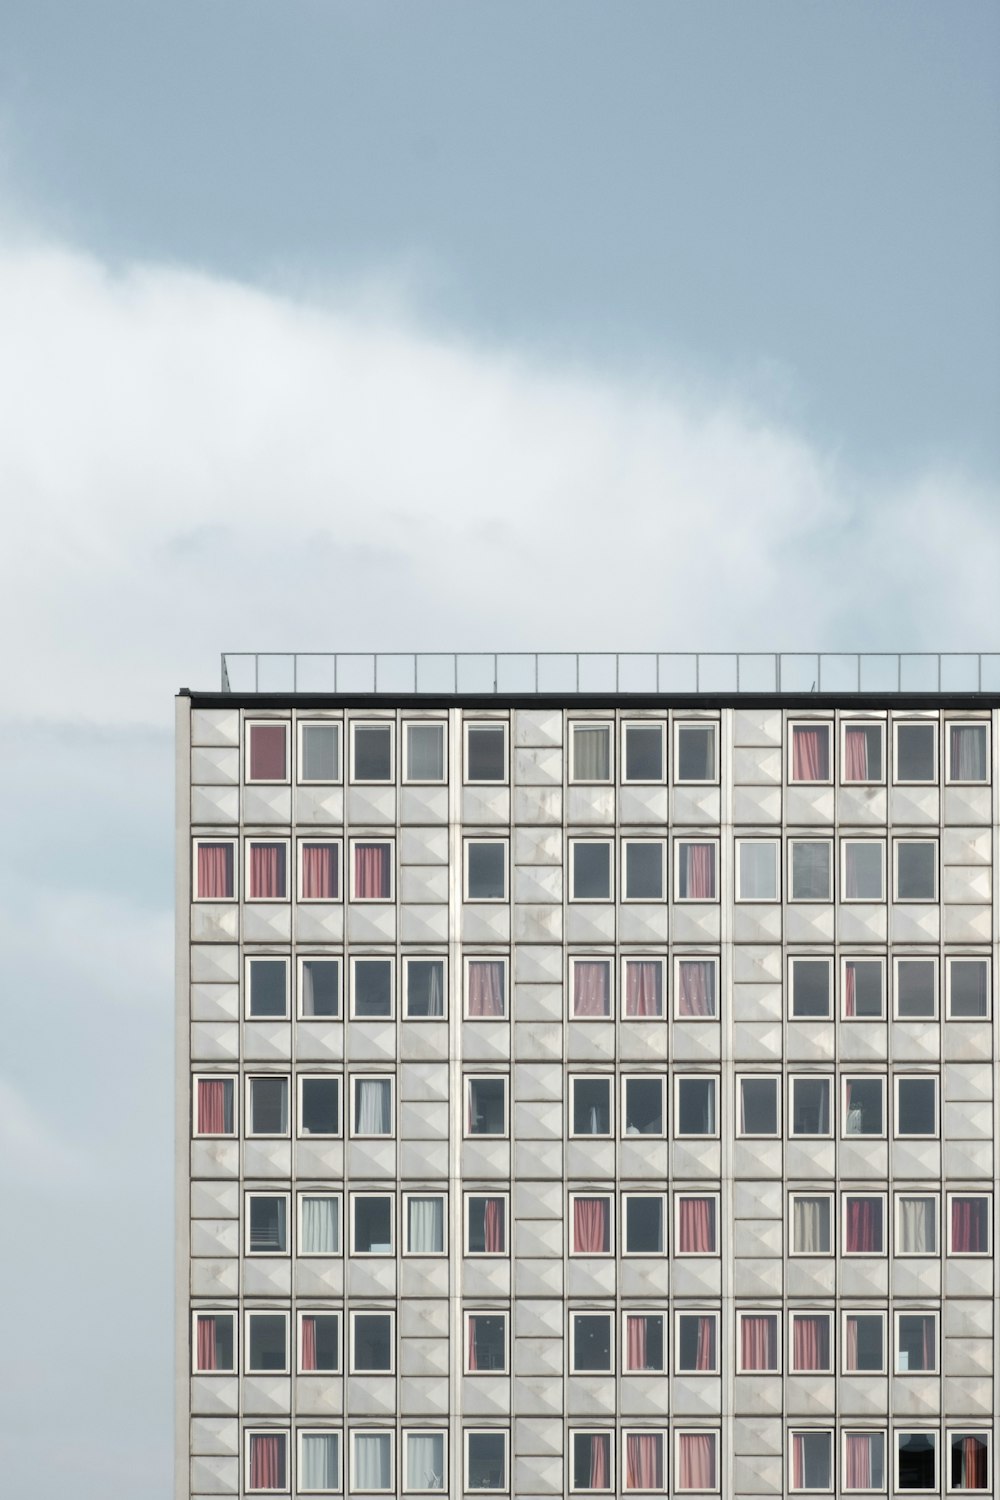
[0,0,1000,1500]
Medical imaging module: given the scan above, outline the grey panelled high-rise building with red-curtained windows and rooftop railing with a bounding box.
[177,657,1000,1500]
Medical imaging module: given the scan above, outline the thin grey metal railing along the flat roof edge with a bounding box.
[222,651,1000,695]
